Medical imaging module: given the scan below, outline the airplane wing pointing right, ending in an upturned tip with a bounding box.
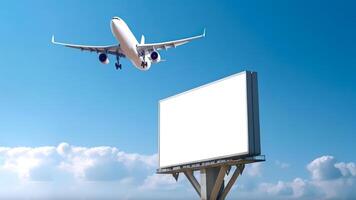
[137,29,205,51]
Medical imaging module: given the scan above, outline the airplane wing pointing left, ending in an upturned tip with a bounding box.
[52,36,125,57]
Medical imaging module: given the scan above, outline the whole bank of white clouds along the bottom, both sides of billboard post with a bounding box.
[0,143,356,199]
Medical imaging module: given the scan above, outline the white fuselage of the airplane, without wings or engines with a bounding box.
[111,18,151,70]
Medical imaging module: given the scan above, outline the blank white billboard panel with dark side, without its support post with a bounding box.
[158,71,260,169]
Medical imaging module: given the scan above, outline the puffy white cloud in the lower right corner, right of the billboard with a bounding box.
[245,156,356,199]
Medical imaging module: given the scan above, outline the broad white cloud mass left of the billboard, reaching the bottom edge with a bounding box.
[0,143,164,199]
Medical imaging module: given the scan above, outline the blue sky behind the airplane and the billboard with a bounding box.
[0,0,356,198]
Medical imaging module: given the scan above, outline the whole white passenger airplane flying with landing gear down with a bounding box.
[52,17,205,71]
